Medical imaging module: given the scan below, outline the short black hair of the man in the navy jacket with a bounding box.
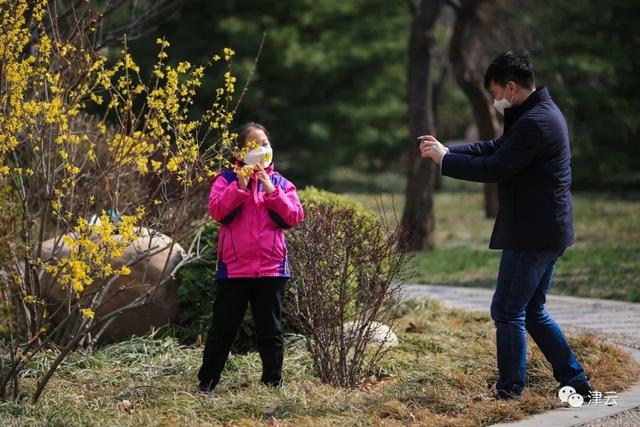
[484,50,535,89]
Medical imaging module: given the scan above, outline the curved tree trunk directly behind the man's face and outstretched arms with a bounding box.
[449,0,500,218]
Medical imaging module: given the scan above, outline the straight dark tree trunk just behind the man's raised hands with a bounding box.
[402,0,444,251]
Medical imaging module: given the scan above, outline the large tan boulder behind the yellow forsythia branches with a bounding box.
[40,229,185,341]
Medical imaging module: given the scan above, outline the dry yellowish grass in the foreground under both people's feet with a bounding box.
[0,301,640,426]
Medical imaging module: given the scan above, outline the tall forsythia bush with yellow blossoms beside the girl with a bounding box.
[0,0,242,400]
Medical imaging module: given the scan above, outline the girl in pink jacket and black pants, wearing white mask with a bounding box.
[198,123,304,393]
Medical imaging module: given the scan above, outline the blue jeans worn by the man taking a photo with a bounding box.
[491,250,588,394]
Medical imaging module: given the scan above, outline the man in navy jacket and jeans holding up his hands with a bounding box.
[418,52,593,399]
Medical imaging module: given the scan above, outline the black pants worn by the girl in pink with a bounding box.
[198,277,287,388]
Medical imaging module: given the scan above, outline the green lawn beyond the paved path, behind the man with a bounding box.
[350,186,640,302]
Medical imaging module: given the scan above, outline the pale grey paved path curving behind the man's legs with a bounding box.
[404,285,640,427]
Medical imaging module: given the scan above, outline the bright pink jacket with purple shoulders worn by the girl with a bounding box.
[209,163,304,279]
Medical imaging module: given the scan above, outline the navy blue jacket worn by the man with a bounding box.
[442,87,574,251]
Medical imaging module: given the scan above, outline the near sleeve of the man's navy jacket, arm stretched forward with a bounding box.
[442,121,544,182]
